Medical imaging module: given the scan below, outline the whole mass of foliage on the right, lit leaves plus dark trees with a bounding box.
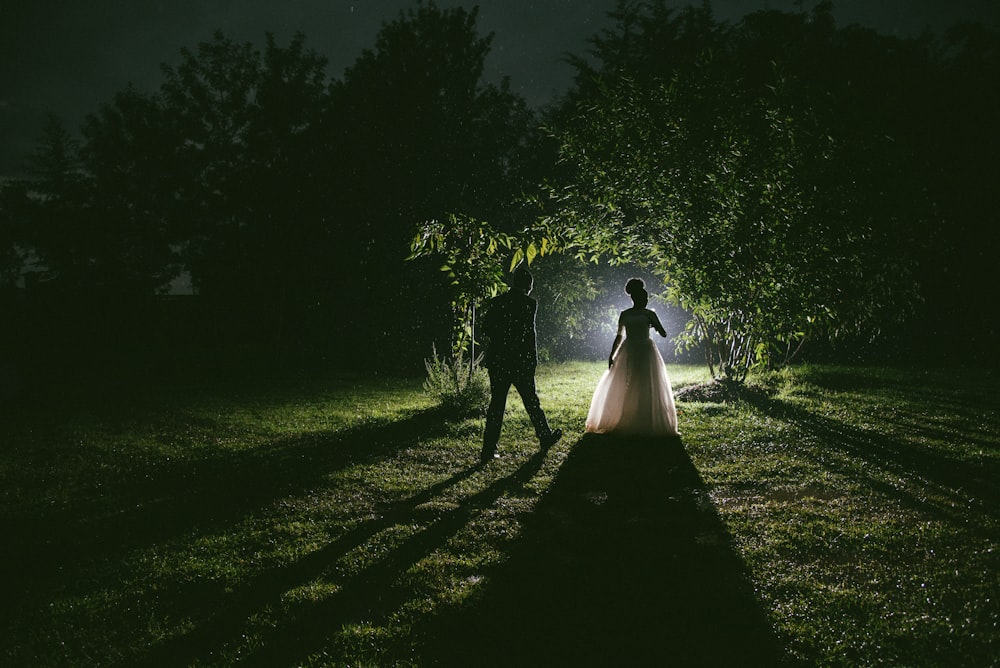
[549,1,997,379]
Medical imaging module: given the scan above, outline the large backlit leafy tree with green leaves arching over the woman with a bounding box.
[549,2,924,380]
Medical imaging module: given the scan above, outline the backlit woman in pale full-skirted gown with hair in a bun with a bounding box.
[587,278,677,436]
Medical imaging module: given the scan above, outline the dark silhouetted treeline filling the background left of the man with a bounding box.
[0,4,539,386]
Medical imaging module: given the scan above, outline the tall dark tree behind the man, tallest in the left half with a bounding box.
[342,2,537,366]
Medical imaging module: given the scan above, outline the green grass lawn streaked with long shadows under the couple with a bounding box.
[0,363,1000,666]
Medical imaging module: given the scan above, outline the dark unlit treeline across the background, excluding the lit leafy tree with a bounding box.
[0,2,1000,394]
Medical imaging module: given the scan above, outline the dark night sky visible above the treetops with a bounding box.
[0,0,1000,176]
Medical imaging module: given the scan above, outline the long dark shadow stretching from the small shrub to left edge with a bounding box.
[0,409,456,619]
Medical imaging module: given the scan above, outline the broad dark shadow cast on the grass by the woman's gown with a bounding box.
[417,435,785,666]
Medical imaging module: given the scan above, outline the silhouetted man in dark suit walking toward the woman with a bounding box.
[482,267,562,461]
